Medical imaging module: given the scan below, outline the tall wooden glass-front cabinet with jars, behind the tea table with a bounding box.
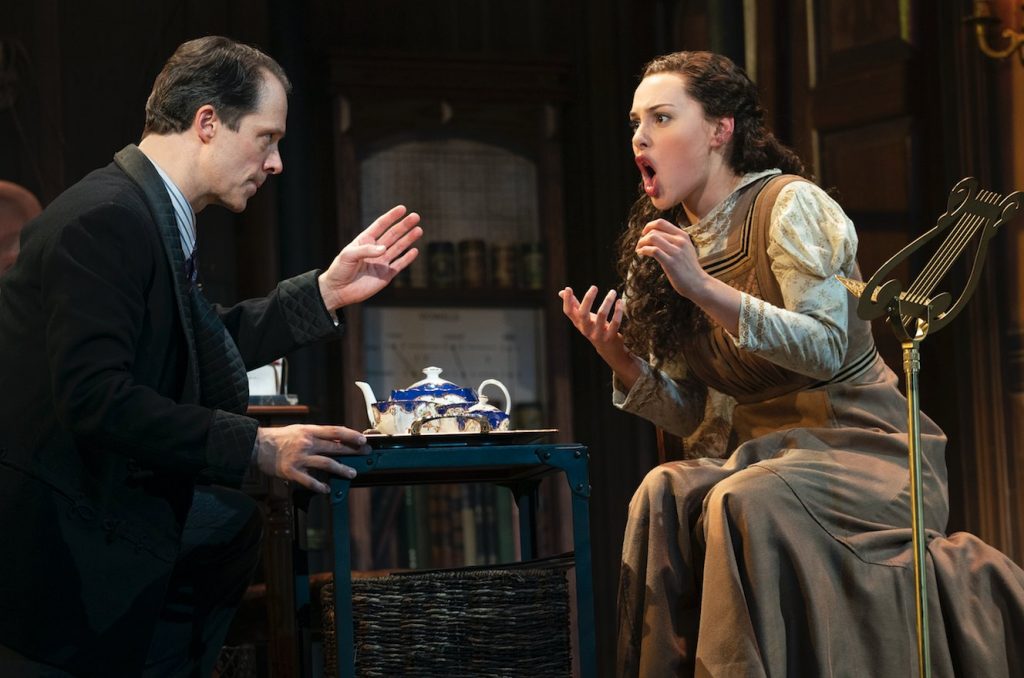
[332,55,572,569]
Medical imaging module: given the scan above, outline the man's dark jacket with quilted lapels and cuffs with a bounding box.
[0,146,340,676]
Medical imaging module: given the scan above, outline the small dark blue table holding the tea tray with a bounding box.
[330,435,596,678]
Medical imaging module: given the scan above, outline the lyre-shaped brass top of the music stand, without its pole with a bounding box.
[837,177,1024,341]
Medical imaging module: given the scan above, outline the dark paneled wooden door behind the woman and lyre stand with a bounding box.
[765,0,1024,560]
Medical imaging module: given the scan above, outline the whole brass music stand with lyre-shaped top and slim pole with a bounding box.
[837,177,1024,678]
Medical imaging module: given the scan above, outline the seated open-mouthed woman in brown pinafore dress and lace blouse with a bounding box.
[559,52,1024,676]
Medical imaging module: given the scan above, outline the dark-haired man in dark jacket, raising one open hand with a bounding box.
[0,37,422,676]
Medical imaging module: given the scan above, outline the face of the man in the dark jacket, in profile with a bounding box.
[205,74,288,212]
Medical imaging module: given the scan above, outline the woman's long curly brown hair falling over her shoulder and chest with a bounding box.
[617,52,806,364]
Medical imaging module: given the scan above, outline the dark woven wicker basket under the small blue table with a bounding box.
[321,566,572,678]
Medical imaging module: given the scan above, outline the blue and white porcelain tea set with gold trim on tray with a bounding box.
[355,367,512,435]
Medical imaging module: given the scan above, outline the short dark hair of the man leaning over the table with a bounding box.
[142,36,292,136]
